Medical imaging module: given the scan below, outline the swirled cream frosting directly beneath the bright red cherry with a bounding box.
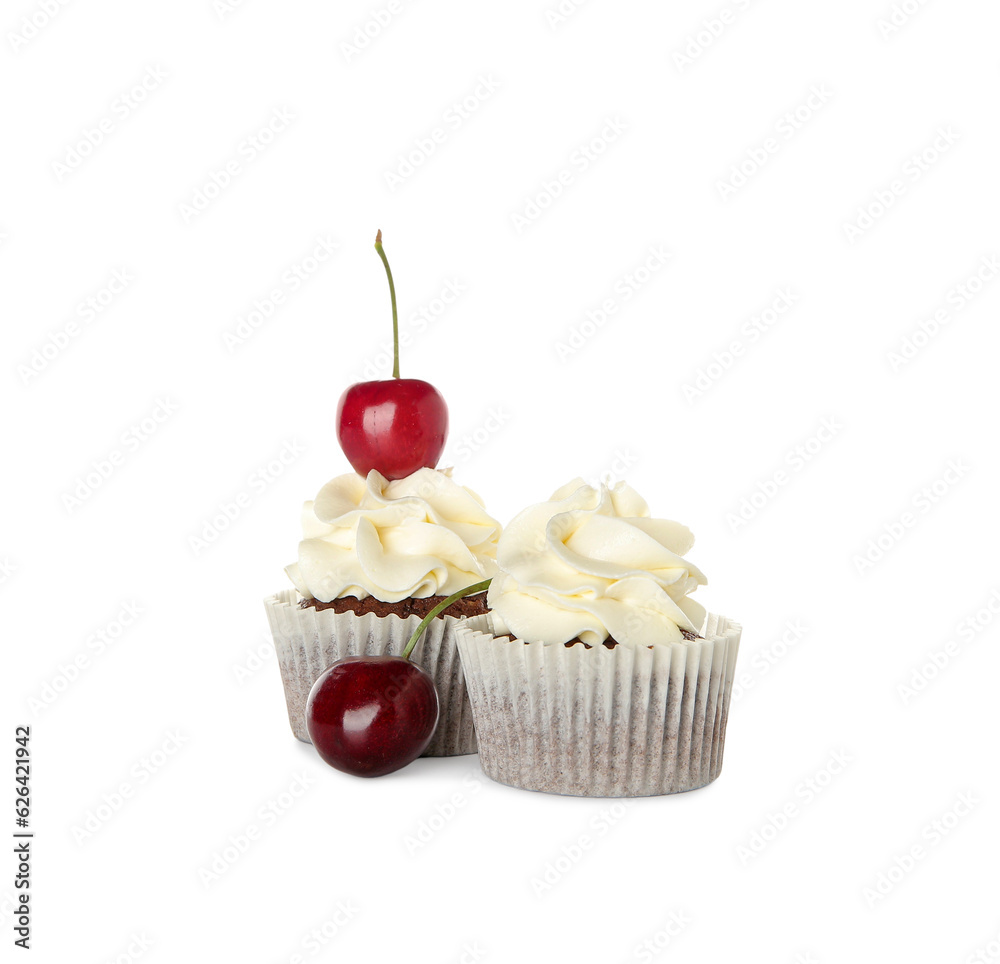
[285,469,500,603]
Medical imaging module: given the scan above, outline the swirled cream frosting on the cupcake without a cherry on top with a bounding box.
[488,479,706,646]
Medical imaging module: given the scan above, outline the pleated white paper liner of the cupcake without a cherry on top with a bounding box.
[456,615,741,797]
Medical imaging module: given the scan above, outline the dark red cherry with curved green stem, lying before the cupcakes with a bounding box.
[305,579,490,777]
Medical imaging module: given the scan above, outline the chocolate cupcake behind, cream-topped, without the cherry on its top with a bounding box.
[265,468,500,756]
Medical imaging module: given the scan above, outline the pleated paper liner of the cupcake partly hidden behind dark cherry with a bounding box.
[264,589,476,756]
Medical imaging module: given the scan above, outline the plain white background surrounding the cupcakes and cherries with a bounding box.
[0,0,1000,964]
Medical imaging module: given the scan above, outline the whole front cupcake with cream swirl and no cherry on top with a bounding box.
[457,479,741,797]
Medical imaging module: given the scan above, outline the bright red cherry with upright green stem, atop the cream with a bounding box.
[337,231,448,479]
